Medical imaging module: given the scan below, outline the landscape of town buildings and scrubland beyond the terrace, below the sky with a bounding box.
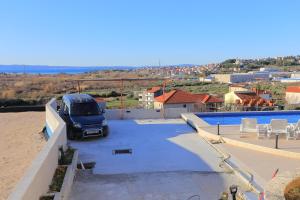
[0,56,300,112]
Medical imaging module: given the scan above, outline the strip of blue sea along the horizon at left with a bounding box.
[0,65,137,74]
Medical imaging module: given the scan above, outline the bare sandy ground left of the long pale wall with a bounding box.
[0,112,46,200]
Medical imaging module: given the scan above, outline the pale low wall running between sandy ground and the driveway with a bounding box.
[8,99,67,200]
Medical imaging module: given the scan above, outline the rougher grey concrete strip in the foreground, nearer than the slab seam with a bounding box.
[70,171,241,200]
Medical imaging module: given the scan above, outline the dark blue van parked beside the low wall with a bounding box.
[59,94,108,139]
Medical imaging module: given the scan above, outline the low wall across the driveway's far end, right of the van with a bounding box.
[105,108,187,120]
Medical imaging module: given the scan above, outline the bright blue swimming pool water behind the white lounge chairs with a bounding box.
[196,111,300,125]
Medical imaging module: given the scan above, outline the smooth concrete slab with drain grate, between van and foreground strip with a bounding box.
[71,120,223,174]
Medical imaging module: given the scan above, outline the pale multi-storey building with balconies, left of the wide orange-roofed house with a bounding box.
[139,87,163,109]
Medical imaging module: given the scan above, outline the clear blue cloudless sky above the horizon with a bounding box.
[0,0,300,66]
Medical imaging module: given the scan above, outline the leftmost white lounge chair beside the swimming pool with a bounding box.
[240,118,266,138]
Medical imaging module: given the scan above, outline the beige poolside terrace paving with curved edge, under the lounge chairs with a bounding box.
[183,114,300,187]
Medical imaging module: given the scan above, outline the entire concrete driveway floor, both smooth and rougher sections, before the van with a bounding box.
[70,120,246,200]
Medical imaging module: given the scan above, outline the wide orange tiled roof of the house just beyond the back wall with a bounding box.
[155,90,223,104]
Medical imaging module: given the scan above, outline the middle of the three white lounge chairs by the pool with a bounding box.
[267,119,290,139]
